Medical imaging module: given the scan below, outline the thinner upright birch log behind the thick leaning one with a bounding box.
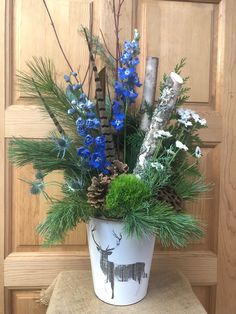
[140,56,159,132]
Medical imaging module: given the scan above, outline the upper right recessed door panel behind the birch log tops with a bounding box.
[138,0,214,103]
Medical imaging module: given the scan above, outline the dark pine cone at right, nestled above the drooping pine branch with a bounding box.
[157,187,183,211]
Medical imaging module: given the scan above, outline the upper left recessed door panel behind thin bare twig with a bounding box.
[11,0,90,104]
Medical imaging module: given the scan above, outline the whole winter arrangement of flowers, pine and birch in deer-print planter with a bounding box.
[9,0,209,305]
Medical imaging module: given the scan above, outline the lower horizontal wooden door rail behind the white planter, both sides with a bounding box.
[5,249,217,288]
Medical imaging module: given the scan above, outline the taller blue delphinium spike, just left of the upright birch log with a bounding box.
[111,30,142,131]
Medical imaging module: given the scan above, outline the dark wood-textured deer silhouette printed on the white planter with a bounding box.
[91,227,147,299]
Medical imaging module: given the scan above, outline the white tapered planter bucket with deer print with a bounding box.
[87,218,155,305]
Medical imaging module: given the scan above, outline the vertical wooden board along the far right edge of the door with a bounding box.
[216,0,236,314]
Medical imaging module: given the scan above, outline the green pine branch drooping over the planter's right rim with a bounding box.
[124,203,204,248]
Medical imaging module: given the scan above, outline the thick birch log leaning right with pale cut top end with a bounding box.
[133,72,183,177]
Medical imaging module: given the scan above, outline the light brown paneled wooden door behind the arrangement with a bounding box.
[0,0,236,314]
